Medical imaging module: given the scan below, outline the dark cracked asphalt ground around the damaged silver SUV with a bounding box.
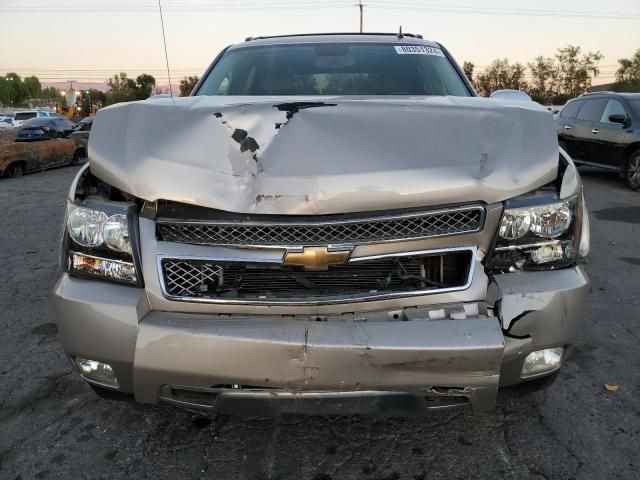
[0,167,640,480]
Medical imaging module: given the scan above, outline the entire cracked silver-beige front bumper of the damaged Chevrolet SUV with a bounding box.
[55,267,588,414]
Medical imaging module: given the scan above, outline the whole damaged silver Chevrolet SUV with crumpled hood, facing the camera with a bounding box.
[55,34,589,414]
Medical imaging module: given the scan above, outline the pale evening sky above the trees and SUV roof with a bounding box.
[0,0,640,84]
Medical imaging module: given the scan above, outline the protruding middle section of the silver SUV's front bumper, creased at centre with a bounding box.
[134,312,504,411]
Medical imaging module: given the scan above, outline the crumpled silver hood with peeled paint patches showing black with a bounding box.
[89,96,558,214]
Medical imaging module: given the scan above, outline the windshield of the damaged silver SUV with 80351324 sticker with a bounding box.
[197,43,471,96]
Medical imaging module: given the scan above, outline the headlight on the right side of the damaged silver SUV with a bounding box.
[485,190,589,274]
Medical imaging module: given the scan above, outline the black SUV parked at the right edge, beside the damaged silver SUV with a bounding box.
[556,92,640,190]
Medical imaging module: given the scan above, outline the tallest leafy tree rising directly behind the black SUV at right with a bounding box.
[555,45,604,97]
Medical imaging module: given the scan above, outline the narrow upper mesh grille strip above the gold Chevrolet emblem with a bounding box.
[157,206,484,246]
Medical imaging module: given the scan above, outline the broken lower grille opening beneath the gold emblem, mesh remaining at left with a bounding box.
[162,251,472,301]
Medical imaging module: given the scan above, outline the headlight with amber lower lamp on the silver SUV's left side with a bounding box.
[62,197,141,285]
